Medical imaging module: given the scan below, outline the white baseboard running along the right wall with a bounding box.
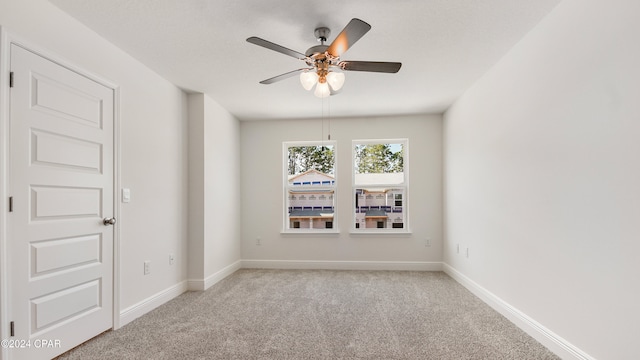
[442,263,595,360]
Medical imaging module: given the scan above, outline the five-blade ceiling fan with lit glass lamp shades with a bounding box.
[247,18,402,98]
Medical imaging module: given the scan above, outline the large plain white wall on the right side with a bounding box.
[444,0,640,359]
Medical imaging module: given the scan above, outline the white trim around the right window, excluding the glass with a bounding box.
[350,139,411,235]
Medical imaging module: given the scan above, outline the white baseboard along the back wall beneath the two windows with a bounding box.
[242,259,442,271]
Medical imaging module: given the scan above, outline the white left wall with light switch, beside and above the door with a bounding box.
[0,0,188,318]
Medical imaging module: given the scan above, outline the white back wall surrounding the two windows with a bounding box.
[240,115,442,268]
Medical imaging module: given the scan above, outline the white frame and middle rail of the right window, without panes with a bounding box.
[350,138,411,235]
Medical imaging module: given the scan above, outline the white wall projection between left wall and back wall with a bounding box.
[188,94,240,290]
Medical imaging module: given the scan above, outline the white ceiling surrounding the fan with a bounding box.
[50,0,560,120]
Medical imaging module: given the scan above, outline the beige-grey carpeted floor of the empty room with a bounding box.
[60,269,558,360]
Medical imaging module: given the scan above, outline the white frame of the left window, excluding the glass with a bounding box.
[280,140,340,235]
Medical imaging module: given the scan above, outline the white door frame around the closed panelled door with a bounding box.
[0,26,121,359]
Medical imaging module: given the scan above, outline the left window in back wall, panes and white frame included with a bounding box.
[283,141,337,232]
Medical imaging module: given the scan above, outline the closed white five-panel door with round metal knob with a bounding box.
[8,44,114,359]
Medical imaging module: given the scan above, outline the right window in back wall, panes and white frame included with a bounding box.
[352,139,408,232]
